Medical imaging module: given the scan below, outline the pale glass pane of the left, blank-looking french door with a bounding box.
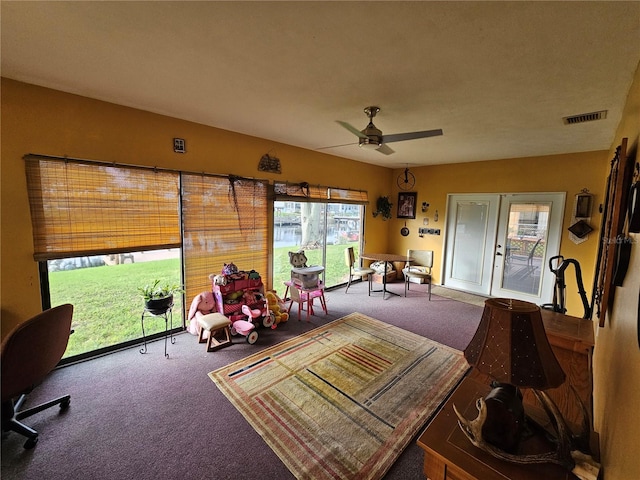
[451,202,489,285]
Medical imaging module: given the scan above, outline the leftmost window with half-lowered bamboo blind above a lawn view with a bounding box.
[25,155,182,358]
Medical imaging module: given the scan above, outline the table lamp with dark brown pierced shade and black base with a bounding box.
[464,298,565,452]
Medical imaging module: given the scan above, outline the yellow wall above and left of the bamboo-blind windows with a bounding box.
[0,79,391,335]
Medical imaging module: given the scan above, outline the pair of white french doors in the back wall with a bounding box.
[444,193,565,304]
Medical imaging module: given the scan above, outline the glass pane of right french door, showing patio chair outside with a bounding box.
[502,203,551,296]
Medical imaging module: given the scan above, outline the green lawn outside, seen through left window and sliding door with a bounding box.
[49,242,358,358]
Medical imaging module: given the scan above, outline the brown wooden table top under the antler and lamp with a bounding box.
[418,377,598,480]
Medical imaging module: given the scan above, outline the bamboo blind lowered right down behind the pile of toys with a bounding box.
[182,173,269,299]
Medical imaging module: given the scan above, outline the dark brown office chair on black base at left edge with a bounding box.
[1,304,73,449]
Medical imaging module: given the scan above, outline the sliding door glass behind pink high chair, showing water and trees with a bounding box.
[272,201,364,295]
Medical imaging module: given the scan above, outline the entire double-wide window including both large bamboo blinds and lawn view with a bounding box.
[25,155,268,359]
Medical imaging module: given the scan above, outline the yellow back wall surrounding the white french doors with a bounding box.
[389,151,609,317]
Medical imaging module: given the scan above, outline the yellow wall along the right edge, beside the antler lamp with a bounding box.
[593,66,640,480]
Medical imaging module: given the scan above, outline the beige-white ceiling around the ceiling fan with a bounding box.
[1,0,640,167]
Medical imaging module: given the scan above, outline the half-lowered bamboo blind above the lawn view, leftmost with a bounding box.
[25,155,181,261]
